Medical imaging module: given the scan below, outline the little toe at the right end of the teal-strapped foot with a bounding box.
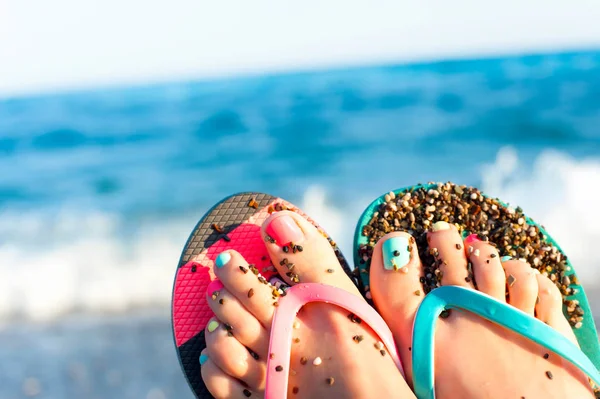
[535,274,577,345]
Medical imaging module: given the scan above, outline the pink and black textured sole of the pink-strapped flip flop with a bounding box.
[171,193,357,399]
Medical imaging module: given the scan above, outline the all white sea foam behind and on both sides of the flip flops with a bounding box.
[0,148,600,321]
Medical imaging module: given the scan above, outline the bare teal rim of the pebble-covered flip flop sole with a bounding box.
[353,184,600,369]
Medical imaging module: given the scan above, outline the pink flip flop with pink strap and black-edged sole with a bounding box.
[172,193,399,399]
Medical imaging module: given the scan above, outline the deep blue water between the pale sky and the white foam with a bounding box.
[0,52,600,219]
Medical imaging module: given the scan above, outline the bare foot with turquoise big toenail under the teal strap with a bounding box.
[370,222,594,399]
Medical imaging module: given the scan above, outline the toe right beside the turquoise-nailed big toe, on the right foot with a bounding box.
[427,221,473,288]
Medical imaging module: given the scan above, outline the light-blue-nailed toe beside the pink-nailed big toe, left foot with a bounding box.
[215,250,278,330]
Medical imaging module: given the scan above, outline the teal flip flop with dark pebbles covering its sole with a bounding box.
[354,183,600,399]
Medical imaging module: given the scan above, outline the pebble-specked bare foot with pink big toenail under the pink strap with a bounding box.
[200,211,414,398]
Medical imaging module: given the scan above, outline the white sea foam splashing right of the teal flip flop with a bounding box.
[481,147,600,288]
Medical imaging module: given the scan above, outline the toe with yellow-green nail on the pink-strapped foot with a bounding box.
[205,318,266,391]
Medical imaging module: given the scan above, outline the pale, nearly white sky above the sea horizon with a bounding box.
[0,0,600,96]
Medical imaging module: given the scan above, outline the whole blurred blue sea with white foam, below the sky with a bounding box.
[0,50,600,399]
